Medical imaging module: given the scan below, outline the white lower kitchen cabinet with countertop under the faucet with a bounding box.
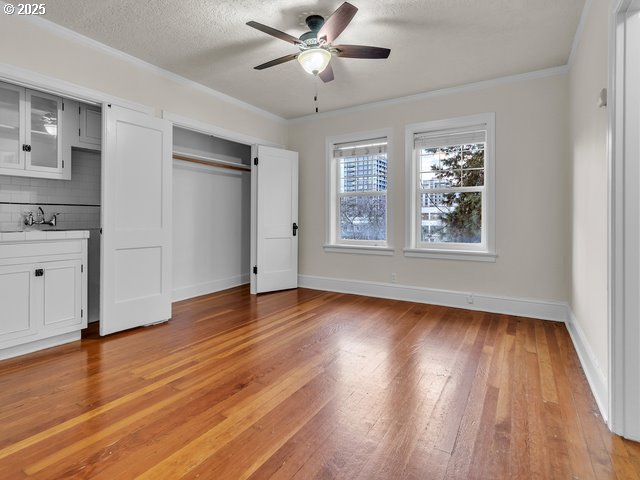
[0,232,88,359]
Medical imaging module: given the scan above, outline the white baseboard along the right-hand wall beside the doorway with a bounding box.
[566,306,609,424]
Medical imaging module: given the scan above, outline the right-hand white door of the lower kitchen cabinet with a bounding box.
[42,260,83,330]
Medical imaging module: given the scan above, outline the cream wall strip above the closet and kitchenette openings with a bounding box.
[0,15,286,145]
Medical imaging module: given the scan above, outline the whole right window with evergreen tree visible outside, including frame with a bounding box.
[405,114,495,261]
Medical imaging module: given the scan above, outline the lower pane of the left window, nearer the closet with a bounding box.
[340,195,387,240]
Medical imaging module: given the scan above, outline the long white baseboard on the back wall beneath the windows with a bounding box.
[298,275,567,322]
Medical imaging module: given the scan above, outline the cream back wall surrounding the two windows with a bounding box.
[289,74,570,302]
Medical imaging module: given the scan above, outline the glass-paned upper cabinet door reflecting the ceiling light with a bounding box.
[26,90,62,173]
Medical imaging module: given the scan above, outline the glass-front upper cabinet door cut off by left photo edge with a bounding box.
[0,83,25,170]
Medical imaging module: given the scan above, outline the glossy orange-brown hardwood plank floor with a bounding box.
[0,288,640,480]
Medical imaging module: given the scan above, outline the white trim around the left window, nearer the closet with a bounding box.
[323,128,395,255]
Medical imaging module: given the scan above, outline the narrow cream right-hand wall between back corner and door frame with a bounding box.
[569,0,611,404]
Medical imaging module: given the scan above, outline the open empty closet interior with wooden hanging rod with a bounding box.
[172,126,251,301]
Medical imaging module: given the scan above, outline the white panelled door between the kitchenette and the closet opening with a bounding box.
[100,104,172,335]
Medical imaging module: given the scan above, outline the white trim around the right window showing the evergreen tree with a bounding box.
[404,112,497,262]
